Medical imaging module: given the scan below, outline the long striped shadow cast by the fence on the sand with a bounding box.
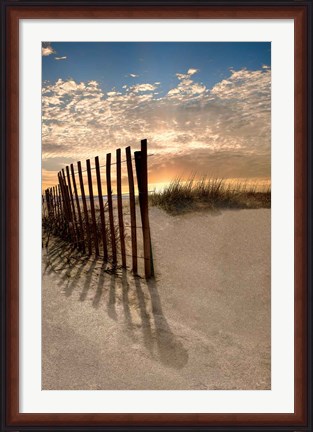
[43,240,188,369]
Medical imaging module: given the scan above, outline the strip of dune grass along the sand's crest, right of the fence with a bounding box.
[149,177,271,215]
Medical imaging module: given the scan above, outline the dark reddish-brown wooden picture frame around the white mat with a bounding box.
[1,0,313,431]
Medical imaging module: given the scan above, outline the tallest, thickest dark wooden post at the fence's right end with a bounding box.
[135,139,154,279]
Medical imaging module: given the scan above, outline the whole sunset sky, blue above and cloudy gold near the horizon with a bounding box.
[42,42,271,189]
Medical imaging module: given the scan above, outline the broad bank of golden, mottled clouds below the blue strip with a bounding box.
[42,68,271,186]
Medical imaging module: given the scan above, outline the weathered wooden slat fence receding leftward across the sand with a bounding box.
[42,140,154,278]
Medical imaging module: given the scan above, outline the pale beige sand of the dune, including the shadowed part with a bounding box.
[42,208,270,389]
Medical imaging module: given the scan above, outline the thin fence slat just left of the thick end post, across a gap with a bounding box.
[126,147,138,274]
